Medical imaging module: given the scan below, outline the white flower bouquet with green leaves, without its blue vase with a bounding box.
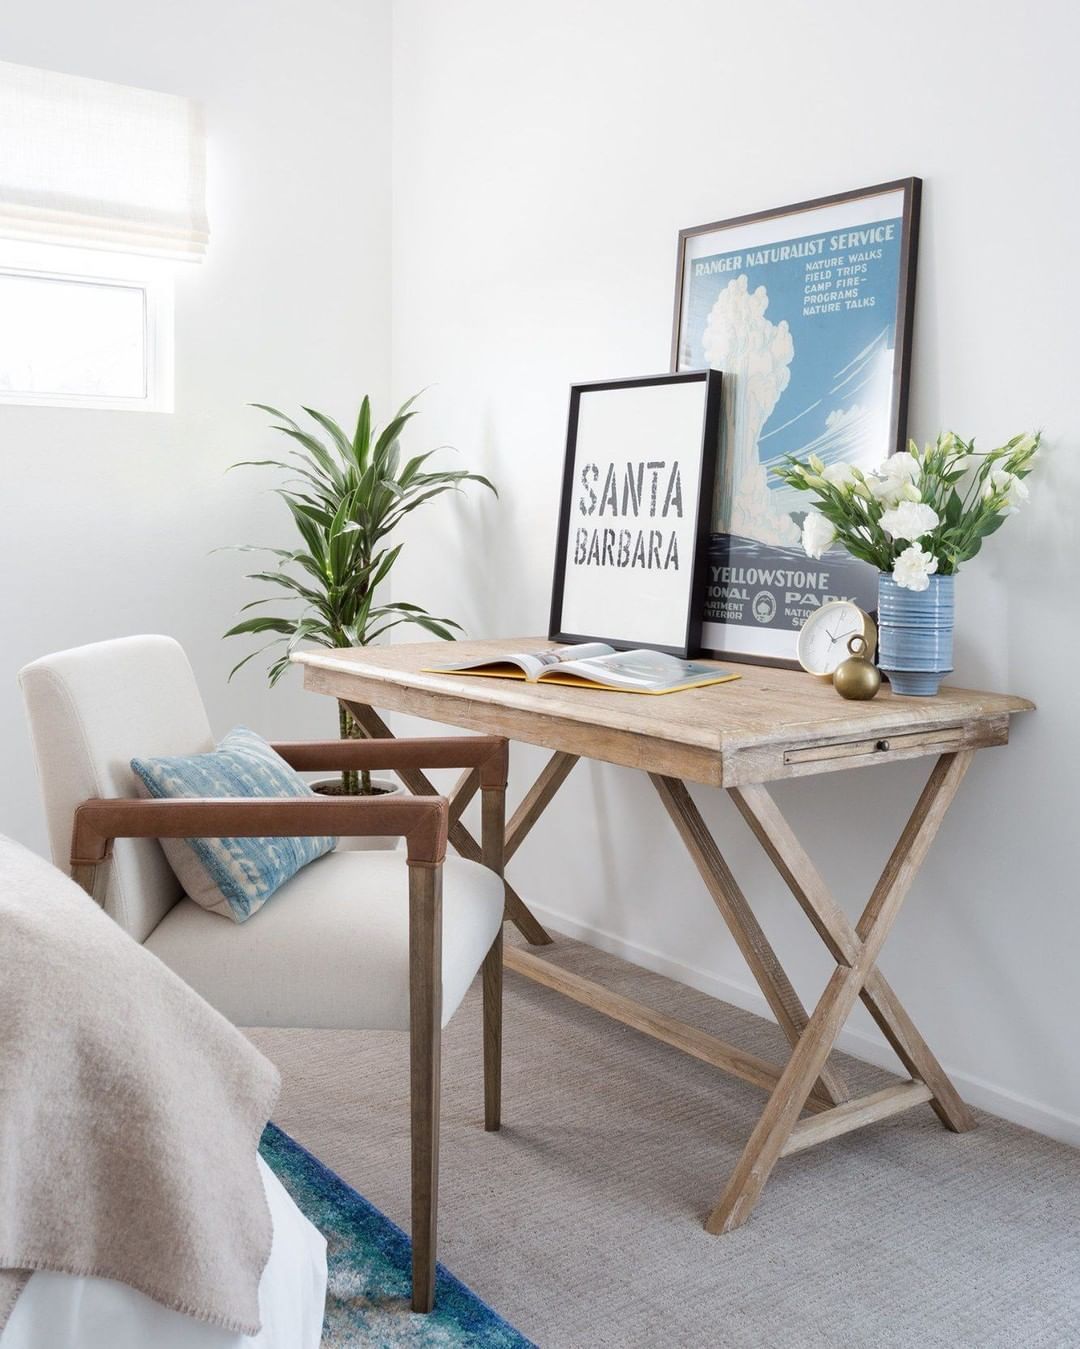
[774,432,1040,591]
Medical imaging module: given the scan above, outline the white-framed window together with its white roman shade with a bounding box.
[0,61,209,411]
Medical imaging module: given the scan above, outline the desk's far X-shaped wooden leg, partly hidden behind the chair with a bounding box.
[345,703,560,946]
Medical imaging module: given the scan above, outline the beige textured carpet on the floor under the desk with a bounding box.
[252,942,1080,1349]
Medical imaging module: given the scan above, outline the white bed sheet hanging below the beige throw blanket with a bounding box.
[0,1157,326,1349]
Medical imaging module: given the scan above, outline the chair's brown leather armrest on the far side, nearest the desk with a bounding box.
[272,735,510,787]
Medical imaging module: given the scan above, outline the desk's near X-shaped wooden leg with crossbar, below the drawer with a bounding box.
[705,750,973,1232]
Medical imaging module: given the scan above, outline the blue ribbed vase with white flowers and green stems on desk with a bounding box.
[774,432,1041,697]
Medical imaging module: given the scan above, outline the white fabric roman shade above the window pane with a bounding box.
[0,61,209,262]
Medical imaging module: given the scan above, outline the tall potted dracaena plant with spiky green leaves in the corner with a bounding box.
[225,394,498,796]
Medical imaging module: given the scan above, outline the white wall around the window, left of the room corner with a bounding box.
[0,0,390,849]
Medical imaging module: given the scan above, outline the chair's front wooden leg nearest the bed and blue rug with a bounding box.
[409,866,442,1311]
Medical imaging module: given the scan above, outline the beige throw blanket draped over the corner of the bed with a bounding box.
[0,835,279,1334]
